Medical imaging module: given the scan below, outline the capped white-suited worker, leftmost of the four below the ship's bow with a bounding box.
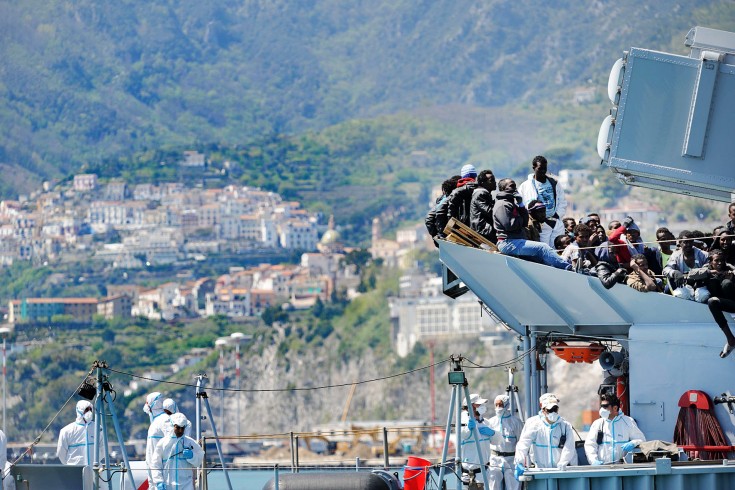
[460,393,495,482]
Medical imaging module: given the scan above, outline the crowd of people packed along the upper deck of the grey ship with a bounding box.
[426,156,735,358]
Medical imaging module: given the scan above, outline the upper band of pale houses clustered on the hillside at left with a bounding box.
[0,170,319,268]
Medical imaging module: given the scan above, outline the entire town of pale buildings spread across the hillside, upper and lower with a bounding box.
[0,161,504,356]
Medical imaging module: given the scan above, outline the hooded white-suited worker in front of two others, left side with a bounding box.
[152,413,204,490]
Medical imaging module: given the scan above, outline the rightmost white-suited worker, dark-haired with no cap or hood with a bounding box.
[584,393,646,466]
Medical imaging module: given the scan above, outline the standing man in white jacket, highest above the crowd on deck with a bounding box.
[518,155,567,246]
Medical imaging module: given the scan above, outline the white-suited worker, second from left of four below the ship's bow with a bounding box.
[488,395,523,490]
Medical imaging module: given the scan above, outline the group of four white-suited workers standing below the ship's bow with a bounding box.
[460,392,646,490]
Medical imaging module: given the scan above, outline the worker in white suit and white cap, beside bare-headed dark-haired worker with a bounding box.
[515,393,577,479]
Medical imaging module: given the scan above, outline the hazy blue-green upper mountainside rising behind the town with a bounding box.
[0,0,735,195]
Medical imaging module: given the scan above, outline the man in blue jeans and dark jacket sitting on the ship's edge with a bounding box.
[493,179,572,270]
